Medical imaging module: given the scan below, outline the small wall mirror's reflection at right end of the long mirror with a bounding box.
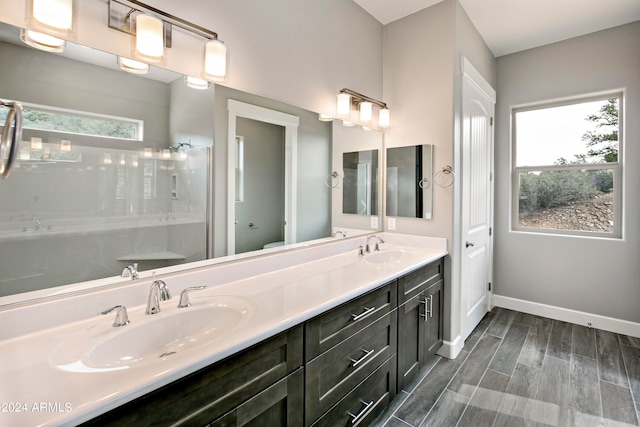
[342,150,379,215]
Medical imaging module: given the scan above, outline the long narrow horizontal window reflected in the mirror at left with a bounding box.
[0,104,142,141]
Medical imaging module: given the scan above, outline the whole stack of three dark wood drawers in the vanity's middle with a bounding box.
[305,281,397,426]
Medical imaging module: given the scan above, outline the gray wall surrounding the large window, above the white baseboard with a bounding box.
[494,22,640,322]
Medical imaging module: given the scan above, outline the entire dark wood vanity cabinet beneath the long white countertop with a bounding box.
[84,260,444,427]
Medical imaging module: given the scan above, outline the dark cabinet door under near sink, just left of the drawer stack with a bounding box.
[209,368,304,427]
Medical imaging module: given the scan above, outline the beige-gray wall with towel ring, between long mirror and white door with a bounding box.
[384,0,496,348]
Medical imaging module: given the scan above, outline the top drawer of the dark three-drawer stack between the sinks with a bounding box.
[305,280,398,362]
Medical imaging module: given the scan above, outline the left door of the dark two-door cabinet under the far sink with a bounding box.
[398,291,426,391]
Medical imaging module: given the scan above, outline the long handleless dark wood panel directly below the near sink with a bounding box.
[81,325,303,427]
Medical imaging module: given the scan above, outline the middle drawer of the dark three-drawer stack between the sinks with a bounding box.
[305,310,397,425]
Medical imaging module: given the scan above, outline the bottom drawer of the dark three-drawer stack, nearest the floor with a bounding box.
[313,355,396,427]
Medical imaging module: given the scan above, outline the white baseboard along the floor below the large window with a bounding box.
[492,294,640,338]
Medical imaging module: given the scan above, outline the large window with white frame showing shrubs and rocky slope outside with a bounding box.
[512,94,623,237]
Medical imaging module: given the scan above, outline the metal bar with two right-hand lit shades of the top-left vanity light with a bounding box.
[109,0,229,81]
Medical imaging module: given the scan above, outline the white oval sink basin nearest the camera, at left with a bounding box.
[50,296,254,372]
